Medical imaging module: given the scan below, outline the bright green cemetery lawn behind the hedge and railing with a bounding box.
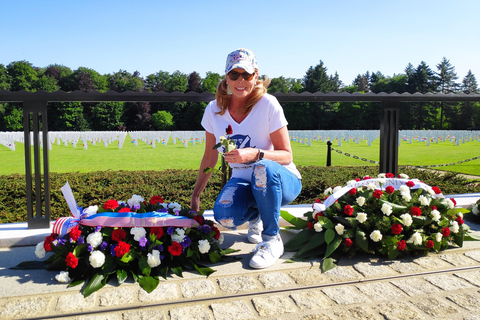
[0,136,480,176]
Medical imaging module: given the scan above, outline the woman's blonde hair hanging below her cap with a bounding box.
[215,69,270,115]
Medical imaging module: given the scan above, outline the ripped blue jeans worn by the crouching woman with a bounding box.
[213,160,302,236]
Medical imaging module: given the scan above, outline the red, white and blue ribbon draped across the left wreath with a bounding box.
[52,182,198,235]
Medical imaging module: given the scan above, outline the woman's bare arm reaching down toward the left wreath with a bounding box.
[190,132,218,211]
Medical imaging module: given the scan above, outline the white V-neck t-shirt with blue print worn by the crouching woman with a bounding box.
[202,93,301,181]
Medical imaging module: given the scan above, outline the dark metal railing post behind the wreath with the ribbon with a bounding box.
[23,101,50,229]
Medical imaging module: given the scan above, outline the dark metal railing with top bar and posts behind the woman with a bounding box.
[0,91,480,229]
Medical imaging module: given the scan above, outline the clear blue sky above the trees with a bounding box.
[0,0,480,85]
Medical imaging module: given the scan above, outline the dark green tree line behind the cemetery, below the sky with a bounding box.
[0,58,480,131]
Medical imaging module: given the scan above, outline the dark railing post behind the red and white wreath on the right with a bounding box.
[380,101,400,175]
